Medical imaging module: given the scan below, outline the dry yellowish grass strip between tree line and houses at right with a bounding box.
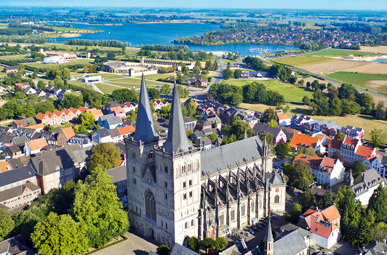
[239,103,387,143]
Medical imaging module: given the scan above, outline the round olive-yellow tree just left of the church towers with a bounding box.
[90,143,121,170]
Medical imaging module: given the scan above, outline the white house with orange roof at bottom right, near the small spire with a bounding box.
[300,205,341,249]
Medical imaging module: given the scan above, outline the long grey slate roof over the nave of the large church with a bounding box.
[201,136,263,174]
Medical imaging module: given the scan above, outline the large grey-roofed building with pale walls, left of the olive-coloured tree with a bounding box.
[31,144,87,194]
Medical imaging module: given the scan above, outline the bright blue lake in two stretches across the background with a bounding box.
[51,23,298,56]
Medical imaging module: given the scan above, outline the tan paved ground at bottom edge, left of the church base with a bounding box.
[93,232,157,255]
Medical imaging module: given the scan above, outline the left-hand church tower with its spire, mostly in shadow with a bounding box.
[125,75,161,241]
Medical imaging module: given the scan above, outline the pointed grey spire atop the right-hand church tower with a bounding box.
[163,81,192,153]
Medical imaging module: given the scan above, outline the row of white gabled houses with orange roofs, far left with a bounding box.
[36,106,87,126]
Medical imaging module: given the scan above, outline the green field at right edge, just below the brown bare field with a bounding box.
[326,71,387,94]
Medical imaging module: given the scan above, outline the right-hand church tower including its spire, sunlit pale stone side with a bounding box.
[155,84,201,245]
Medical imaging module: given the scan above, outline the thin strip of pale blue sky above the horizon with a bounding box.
[0,0,387,11]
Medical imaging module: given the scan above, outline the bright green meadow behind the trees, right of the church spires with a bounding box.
[220,80,313,101]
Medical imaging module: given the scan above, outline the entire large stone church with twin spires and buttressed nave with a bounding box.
[125,76,286,246]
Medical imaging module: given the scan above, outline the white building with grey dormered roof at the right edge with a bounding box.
[349,168,385,206]
